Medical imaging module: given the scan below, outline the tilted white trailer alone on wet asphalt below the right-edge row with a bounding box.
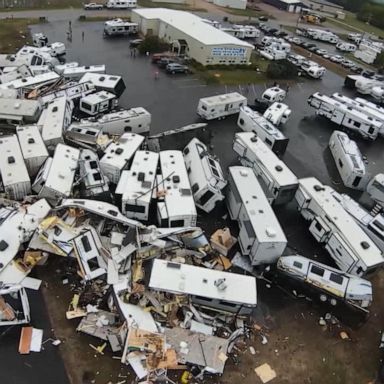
[329,131,368,191]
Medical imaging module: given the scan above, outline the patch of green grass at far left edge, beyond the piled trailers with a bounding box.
[0,19,40,53]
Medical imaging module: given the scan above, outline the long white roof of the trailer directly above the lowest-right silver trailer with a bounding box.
[299,177,384,268]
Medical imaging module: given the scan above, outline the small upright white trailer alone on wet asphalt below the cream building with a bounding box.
[197,92,247,120]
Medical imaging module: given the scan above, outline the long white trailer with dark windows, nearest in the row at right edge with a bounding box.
[308,92,382,140]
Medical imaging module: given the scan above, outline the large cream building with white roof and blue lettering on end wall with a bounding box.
[131,8,254,65]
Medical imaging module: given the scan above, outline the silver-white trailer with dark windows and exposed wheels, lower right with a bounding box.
[277,255,372,311]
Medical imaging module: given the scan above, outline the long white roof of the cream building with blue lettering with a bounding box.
[132,8,254,49]
